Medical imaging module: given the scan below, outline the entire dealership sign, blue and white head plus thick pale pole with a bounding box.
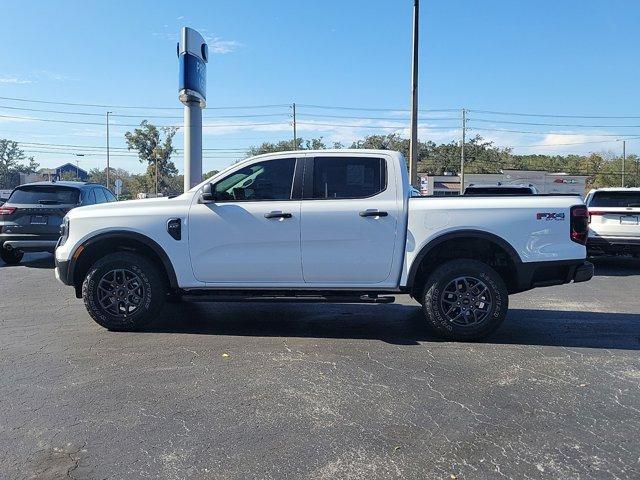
[178,27,209,192]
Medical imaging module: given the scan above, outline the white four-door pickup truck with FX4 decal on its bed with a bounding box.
[55,150,593,340]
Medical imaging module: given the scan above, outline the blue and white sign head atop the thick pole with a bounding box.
[178,27,209,108]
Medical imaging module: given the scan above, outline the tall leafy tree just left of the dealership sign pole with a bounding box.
[124,120,178,194]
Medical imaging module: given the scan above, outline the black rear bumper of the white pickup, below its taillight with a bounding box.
[511,260,594,293]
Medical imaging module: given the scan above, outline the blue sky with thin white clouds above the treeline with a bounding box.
[0,0,640,171]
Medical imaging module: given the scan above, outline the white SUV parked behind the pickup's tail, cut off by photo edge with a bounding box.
[586,188,640,257]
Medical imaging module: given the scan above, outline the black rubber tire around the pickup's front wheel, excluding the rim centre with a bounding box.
[82,252,167,332]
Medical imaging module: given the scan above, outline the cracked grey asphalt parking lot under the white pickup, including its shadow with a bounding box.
[0,254,640,479]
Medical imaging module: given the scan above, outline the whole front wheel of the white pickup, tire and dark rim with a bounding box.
[82,252,167,332]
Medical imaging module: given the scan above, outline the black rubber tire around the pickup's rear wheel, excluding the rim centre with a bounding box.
[421,259,509,341]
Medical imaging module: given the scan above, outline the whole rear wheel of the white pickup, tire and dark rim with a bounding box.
[421,259,509,341]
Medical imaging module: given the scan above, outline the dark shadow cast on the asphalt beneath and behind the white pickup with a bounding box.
[144,303,640,350]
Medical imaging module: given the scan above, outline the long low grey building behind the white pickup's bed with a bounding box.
[420,169,587,196]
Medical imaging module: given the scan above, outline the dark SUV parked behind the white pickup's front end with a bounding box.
[0,182,116,264]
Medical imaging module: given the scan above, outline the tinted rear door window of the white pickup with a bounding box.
[304,157,387,199]
